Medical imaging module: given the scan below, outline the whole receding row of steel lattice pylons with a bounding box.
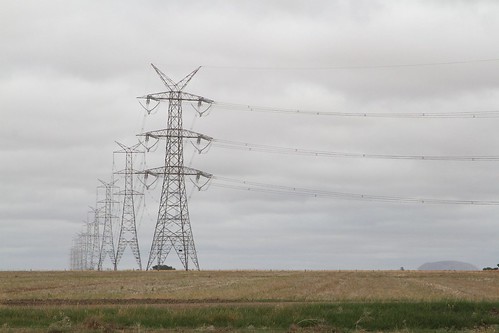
[70,64,213,270]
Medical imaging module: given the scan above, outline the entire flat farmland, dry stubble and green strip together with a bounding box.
[0,271,499,332]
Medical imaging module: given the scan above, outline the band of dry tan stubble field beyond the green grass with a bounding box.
[0,271,499,303]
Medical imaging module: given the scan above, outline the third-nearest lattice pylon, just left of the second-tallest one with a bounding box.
[97,179,116,271]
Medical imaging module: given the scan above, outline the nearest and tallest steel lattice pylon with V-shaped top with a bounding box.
[139,64,213,271]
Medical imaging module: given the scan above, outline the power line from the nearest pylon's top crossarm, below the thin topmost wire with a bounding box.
[214,102,499,119]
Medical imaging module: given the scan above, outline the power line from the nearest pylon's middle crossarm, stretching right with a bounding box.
[212,139,499,162]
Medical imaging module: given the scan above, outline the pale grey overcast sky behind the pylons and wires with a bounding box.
[0,0,499,270]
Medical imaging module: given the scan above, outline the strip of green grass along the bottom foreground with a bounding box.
[0,302,499,332]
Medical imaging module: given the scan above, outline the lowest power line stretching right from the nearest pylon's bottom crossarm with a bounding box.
[211,176,499,206]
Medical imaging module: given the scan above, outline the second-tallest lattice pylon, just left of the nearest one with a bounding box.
[114,142,144,270]
